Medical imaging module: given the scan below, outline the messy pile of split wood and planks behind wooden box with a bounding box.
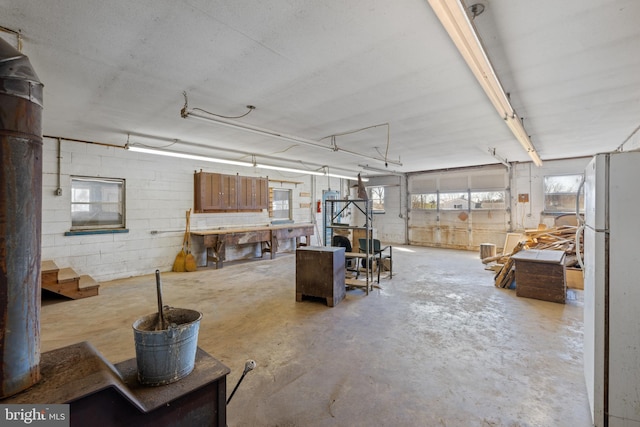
[482,225,582,288]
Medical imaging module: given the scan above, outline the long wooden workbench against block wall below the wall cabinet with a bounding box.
[191,224,313,268]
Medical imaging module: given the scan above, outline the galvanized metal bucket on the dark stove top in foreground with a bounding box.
[133,308,202,386]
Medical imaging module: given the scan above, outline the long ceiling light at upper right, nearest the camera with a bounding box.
[429,0,542,166]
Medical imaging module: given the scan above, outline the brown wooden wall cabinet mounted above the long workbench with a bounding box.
[194,171,269,213]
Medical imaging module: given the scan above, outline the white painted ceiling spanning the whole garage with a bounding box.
[0,0,640,175]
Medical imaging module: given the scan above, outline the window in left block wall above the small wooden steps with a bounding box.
[71,177,125,230]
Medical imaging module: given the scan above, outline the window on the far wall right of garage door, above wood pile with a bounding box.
[544,174,584,214]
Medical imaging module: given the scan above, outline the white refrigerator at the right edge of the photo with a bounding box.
[584,152,640,427]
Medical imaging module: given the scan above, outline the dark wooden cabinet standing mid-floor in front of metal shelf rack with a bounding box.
[296,246,346,307]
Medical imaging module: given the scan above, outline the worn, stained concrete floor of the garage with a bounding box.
[41,246,591,427]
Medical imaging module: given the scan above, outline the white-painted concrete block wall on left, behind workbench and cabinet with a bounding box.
[42,138,320,281]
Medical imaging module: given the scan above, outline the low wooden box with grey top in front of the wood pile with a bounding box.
[511,249,567,304]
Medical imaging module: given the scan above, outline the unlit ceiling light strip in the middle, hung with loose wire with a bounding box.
[180,103,402,166]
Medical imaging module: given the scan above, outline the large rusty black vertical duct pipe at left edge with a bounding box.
[0,38,42,399]
